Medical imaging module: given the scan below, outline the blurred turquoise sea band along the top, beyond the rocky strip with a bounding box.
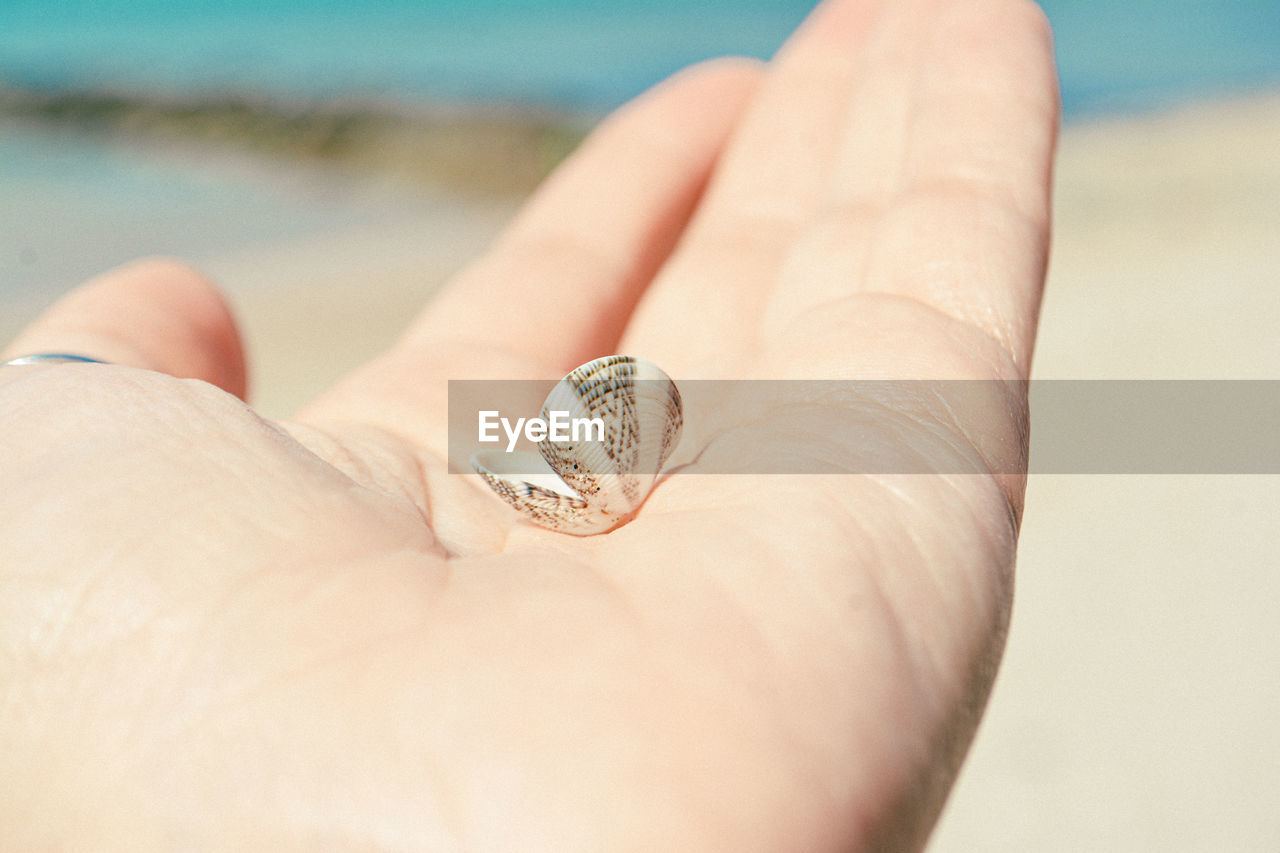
[0,0,1280,118]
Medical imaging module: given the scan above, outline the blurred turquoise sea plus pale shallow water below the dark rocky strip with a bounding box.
[0,0,1280,306]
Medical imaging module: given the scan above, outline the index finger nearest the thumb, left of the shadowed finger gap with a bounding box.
[394,60,759,375]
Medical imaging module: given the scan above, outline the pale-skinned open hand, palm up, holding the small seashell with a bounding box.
[0,0,1057,850]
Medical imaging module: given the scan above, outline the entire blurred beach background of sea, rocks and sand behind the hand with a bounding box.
[0,0,1280,850]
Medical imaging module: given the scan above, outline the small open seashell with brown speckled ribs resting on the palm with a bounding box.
[471,355,684,535]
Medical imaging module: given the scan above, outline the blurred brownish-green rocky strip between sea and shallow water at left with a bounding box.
[0,81,596,196]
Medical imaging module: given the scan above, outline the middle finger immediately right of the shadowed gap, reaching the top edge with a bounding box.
[626,0,899,373]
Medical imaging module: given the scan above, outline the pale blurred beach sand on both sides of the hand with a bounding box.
[0,86,1280,853]
